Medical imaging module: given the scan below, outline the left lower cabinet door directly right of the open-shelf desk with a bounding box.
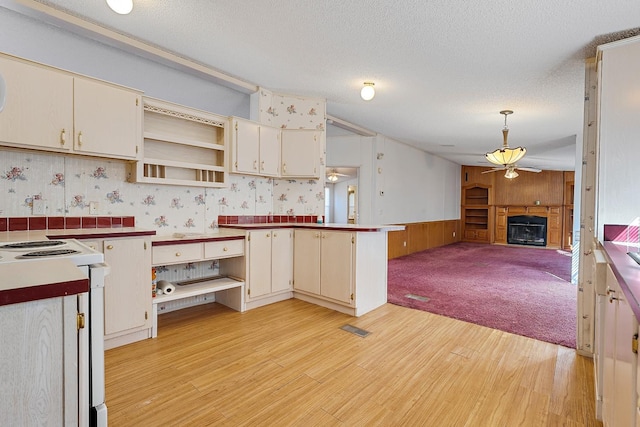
[247,230,271,298]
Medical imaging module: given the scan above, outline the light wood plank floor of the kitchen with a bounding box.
[106,300,602,427]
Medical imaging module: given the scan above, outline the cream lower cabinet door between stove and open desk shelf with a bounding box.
[103,239,151,335]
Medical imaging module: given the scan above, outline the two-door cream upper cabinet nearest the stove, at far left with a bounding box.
[0,55,142,159]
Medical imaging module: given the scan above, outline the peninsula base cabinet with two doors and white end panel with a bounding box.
[293,230,387,316]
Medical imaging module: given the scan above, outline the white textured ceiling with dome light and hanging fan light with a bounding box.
[4,0,640,170]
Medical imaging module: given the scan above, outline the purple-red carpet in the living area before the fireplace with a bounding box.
[388,243,577,348]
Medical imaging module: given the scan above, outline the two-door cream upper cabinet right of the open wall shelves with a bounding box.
[231,117,280,176]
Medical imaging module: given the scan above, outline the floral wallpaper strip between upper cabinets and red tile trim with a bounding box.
[0,148,324,234]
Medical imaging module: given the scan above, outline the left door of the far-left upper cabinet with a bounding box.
[0,56,73,151]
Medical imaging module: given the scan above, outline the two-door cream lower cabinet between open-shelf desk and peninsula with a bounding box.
[246,229,293,308]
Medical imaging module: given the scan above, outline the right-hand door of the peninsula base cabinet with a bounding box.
[320,231,355,304]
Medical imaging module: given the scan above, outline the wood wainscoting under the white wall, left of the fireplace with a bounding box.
[388,219,460,259]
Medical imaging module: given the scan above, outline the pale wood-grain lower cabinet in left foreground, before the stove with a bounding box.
[0,293,80,426]
